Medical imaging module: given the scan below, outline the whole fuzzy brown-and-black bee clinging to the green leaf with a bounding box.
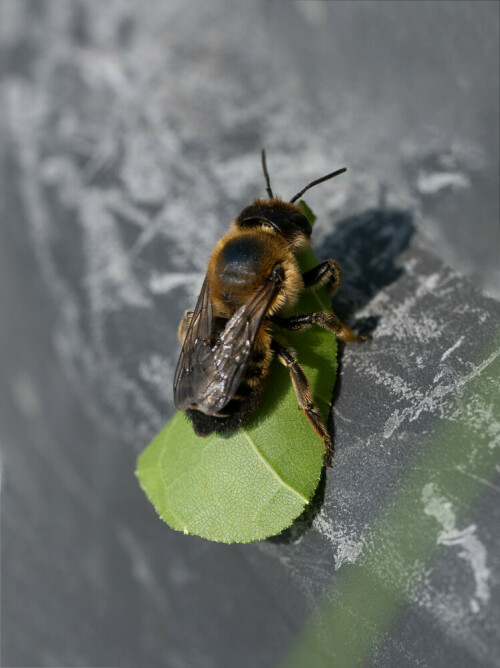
[174,150,370,465]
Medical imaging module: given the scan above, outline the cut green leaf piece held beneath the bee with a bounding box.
[137,219,337,543]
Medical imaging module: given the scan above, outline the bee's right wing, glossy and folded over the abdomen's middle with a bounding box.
[196,274,281,415]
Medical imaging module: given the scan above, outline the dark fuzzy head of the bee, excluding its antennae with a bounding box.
[234,197,312,248]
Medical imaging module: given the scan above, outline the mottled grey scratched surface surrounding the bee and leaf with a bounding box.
[0,0,500,668]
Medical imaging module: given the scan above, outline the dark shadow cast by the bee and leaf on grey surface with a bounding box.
[268,209,415,543]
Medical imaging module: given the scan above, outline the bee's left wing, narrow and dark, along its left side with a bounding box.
[174,278,215,411]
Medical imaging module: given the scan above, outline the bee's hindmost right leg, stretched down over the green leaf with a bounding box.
[271,339,333,466]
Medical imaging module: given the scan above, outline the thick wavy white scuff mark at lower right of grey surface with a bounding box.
[422,483,491,613]
